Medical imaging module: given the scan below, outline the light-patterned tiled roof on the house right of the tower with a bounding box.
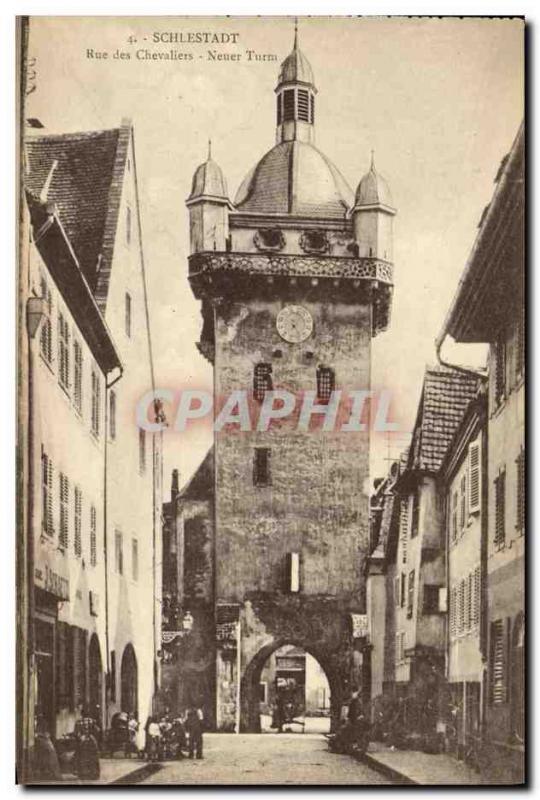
[407,367,480,472]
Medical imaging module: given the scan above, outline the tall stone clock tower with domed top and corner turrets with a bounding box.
[188,26,395,731]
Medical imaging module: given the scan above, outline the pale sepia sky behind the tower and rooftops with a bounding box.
[27,17,524,494]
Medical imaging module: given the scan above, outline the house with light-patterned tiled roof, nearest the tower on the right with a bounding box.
[368,367,479,746]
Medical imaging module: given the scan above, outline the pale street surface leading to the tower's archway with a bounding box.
[138,733,391,786]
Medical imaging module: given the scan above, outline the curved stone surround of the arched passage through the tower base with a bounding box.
[240,638,343,733]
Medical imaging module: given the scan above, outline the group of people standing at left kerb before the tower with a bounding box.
[145,705,204,761]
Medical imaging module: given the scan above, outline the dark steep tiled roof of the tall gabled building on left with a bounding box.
[25,122,131,310]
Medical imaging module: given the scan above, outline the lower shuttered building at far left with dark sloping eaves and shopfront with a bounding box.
[27,193,121,737]
